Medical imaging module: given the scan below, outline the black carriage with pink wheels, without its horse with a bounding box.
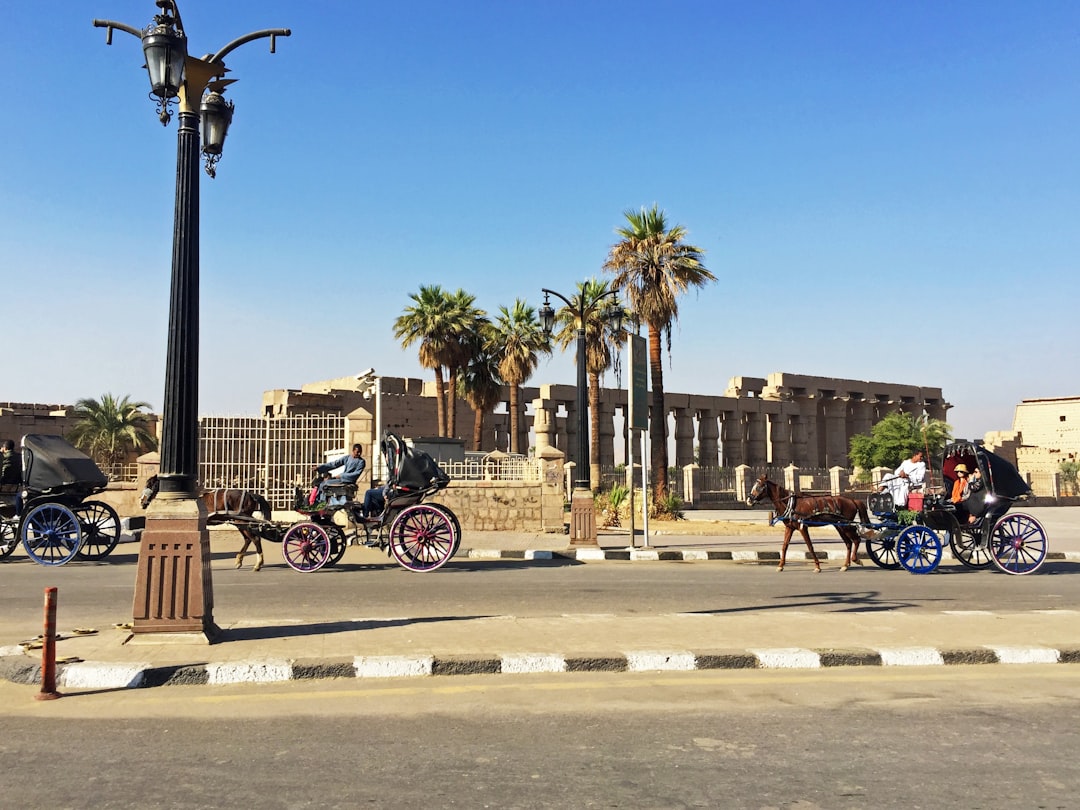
[281,432,461,572]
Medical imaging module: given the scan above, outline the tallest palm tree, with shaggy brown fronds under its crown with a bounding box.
[604,204,716,503]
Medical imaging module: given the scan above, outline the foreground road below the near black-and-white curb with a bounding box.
[0,666,1080,810]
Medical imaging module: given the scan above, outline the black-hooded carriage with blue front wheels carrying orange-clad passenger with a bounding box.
[866,442,1047,575]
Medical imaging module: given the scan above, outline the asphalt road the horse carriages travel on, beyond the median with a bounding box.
[0,546,1080,645]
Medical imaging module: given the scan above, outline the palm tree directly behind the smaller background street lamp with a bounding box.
[552,279,624,491]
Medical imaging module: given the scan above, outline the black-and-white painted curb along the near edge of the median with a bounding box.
[0,646,1080,689]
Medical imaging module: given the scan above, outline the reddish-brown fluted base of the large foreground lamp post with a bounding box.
[132,496,217,639]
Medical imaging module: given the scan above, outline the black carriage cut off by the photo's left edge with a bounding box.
[0,433,120,565]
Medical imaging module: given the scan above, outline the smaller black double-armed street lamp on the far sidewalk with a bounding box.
[540,287,623,545]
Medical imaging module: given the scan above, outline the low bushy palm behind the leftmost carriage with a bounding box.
[67,394,158,467]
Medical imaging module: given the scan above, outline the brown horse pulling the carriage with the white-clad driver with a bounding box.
[746,475,869,573]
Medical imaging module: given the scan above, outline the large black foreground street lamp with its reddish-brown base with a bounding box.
[94,0,291,636]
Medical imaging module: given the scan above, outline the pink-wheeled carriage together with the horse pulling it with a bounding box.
[143,432,461,573]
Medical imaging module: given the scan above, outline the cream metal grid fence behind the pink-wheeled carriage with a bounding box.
[199,414,348,509]
